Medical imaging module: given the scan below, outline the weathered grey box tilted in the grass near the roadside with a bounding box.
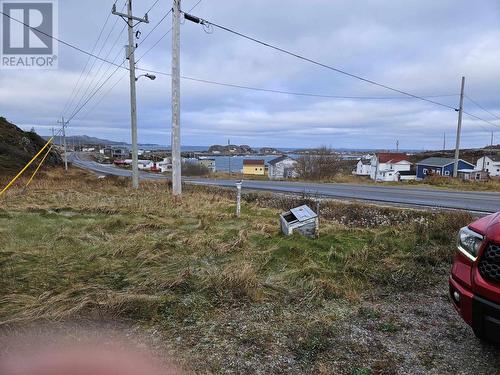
[280,205,319,237]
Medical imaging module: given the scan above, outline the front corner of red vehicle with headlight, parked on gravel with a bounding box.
[450,212,500,344]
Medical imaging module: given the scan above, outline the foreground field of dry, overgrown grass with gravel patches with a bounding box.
[0,170,500,375]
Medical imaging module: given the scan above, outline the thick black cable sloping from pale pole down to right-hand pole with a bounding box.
[184,16,455,110]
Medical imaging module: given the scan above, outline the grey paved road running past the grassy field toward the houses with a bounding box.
[69,154,500,213]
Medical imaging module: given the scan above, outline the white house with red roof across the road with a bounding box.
[370,152,411,181]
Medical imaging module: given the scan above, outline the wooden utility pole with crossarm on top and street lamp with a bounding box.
[111,0,149,189]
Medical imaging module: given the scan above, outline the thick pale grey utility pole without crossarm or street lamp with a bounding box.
[171,0,182,196]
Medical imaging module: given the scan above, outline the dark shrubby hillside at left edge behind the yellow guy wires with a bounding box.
[0,117,61,176]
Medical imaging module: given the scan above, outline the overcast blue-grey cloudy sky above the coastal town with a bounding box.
[0,0,500,149]
